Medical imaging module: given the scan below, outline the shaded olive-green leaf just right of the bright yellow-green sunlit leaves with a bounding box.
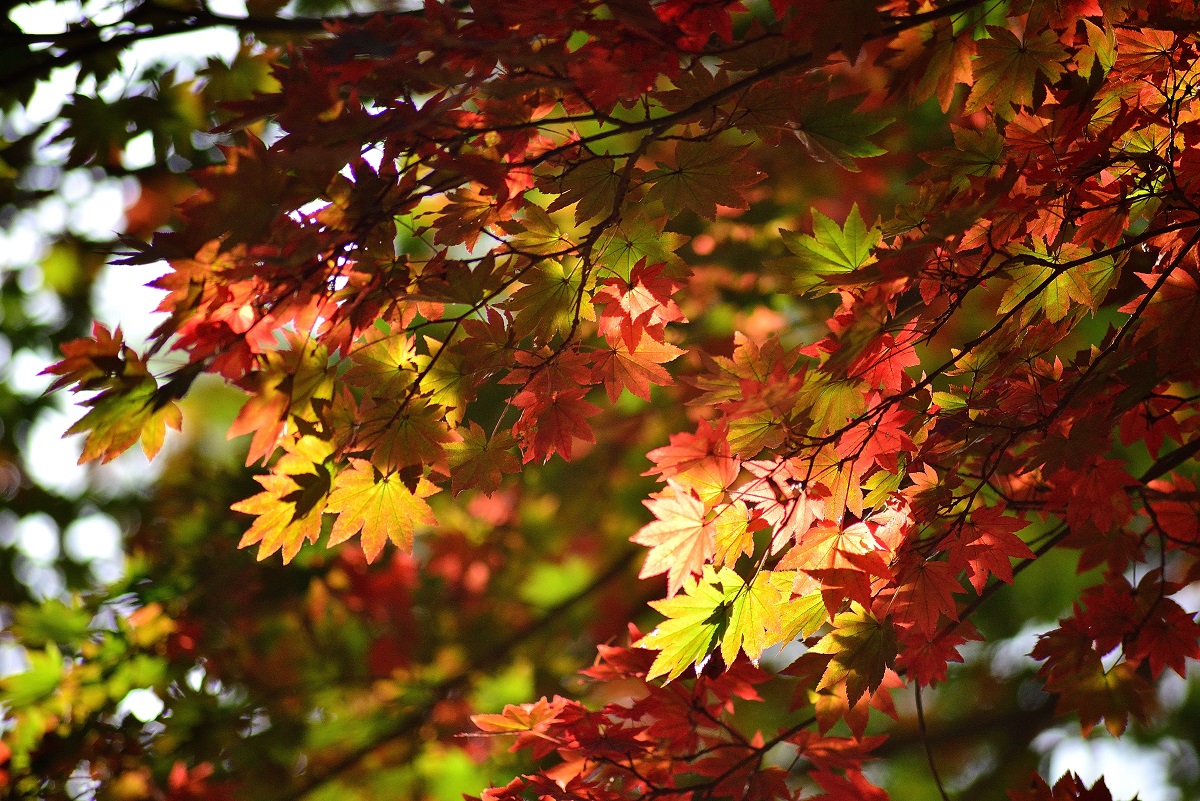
[812,603,896,706]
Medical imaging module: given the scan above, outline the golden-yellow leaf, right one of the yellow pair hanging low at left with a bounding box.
[325,458,438,562]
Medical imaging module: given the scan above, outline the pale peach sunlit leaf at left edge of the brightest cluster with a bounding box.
[630,482,716,596]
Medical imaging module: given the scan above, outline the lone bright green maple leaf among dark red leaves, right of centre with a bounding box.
[779,203,882,294]
